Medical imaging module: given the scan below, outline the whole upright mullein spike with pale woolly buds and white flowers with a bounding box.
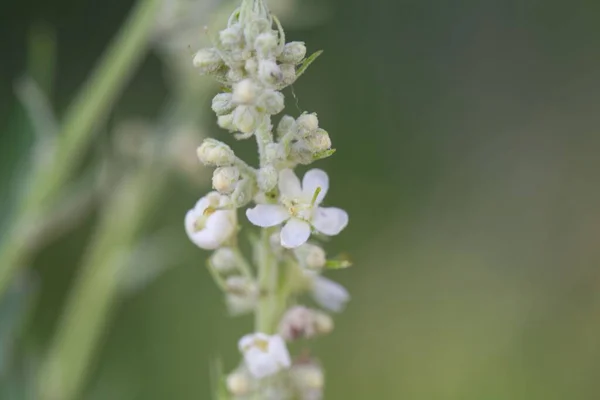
[184,0,349,400]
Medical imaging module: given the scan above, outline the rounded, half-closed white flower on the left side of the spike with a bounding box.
[185,192,237,250]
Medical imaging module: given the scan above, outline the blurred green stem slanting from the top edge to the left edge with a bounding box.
[0,0,160,297]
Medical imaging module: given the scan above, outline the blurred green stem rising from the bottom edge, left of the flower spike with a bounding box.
[37,162,164,400]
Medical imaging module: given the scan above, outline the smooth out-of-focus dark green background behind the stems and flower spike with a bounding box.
[0,0,600,400]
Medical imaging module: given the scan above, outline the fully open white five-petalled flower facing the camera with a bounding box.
[246,169,348,248]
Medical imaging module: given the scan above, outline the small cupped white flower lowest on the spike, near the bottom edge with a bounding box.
[238,333,291,379]
